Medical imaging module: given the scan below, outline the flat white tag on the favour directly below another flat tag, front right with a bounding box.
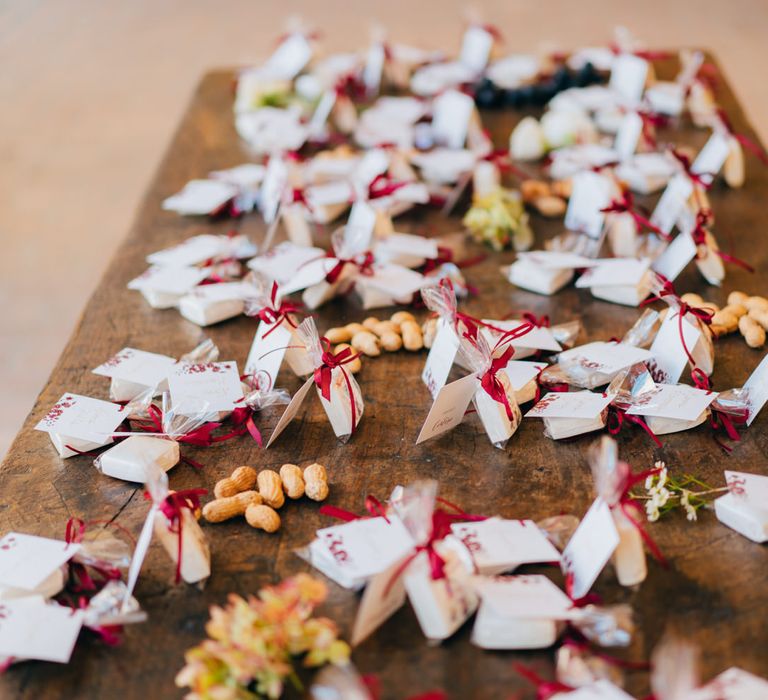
[477,574,573,620]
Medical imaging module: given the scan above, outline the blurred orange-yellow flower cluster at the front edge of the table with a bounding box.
[176,574,350,700]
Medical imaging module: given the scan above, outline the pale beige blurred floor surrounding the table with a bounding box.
[0,0,768,455]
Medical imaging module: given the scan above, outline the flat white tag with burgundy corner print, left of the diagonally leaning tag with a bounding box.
[451,518,560,574]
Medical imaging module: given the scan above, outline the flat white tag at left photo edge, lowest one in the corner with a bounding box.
[0,596,83,664]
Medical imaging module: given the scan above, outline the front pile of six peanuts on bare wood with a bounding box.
[203,463,328,532]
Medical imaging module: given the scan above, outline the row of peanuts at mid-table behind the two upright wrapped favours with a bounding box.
[325,311,424,360]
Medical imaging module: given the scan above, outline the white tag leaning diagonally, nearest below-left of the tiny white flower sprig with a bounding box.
[560,498,619,600]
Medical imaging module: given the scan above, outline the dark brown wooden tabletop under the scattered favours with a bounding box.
[0,56,768,700]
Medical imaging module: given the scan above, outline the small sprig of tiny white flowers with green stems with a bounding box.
[630,462,728,522]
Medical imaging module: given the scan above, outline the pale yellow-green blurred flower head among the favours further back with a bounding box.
[463,187,533,250]
